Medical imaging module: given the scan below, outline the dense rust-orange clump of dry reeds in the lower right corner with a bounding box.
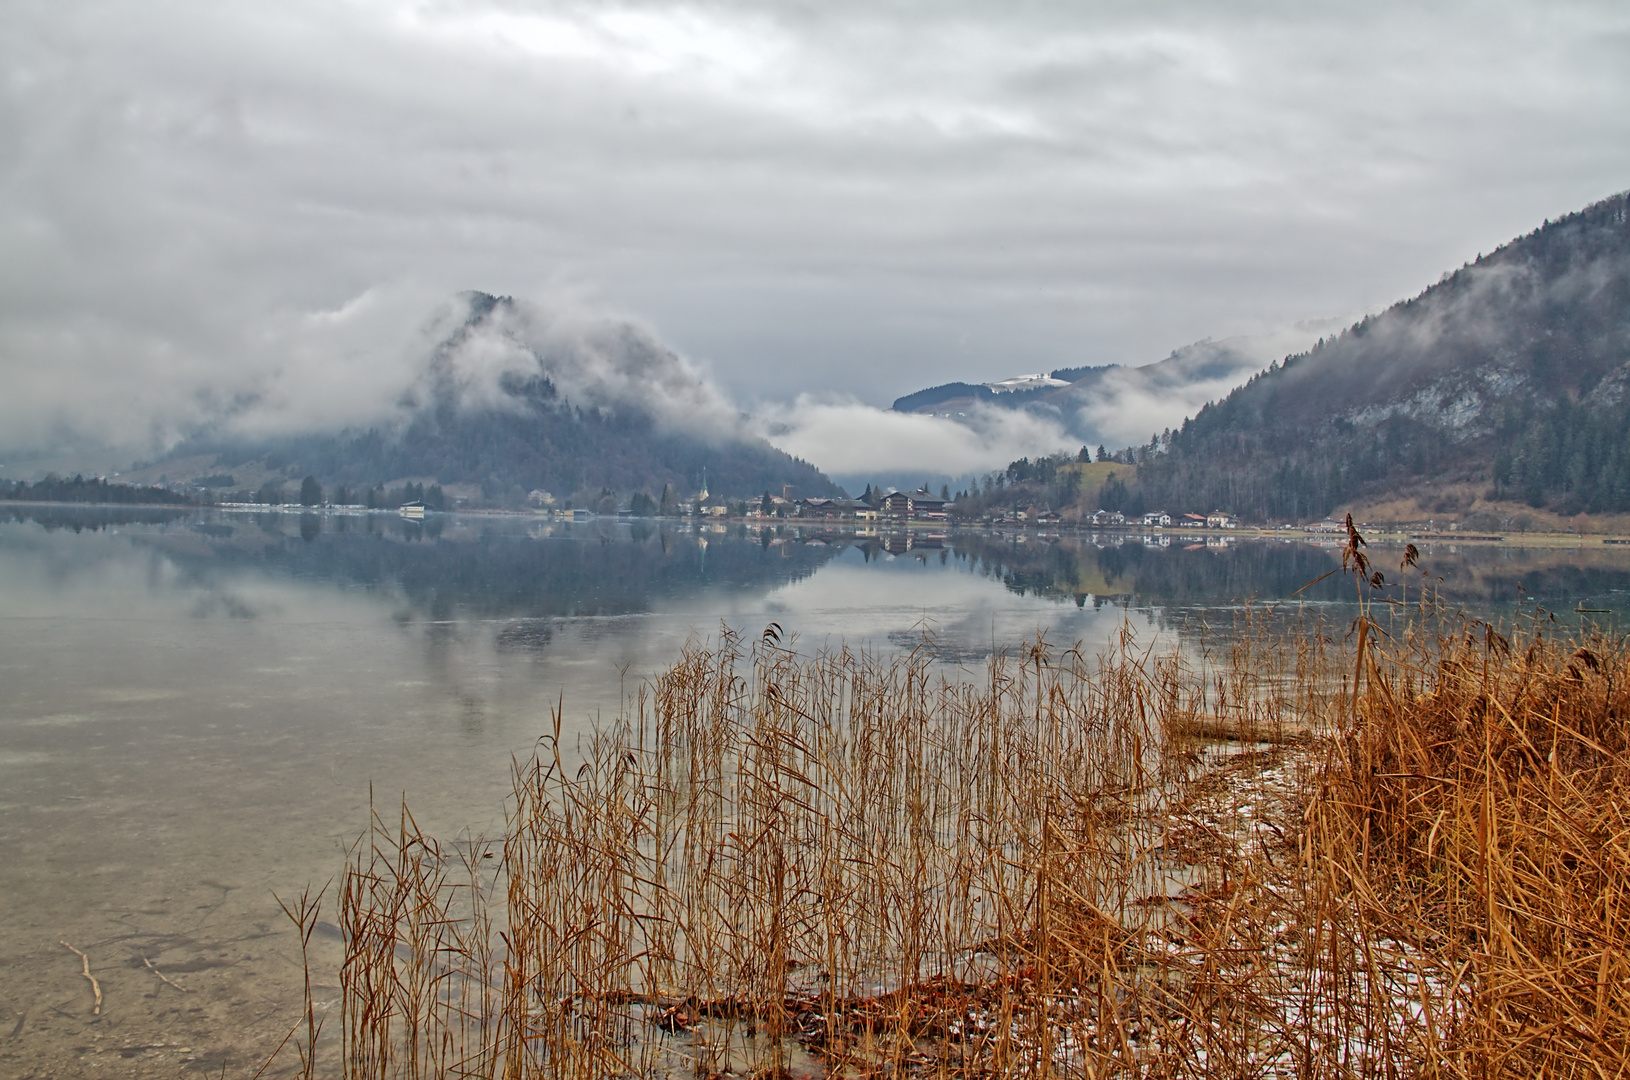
[1304,624,1630,1077]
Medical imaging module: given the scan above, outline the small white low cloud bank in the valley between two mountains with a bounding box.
[758,394,1081,476]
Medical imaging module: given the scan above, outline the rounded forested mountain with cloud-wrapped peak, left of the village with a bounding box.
[143,293,841,505]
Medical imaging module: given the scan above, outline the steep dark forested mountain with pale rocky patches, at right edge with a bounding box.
[1138,194,1630,520]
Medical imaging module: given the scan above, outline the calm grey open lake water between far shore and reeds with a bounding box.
[9,507,1630,1077]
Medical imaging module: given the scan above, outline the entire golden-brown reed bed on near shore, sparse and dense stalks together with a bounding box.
[286,573,1630,1080]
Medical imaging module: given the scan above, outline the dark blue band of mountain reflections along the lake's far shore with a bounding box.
[12,507,1630,625]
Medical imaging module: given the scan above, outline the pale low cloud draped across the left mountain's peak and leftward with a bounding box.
[3,285,747,459]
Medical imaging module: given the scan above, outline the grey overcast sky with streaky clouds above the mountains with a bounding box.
[0,0,1630,469]
